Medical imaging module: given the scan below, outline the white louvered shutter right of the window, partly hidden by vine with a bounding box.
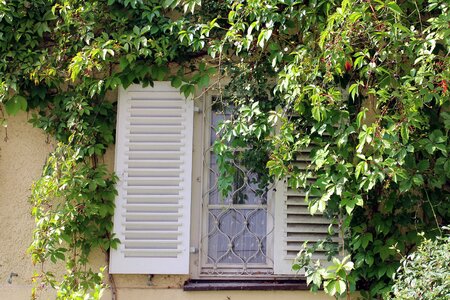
[274,151,338,275]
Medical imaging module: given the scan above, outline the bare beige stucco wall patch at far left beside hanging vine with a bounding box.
[0,113,52,299]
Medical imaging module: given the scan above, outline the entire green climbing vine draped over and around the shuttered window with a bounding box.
[0,0,450,299]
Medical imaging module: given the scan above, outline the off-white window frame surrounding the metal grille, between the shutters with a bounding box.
[190,91,276,280]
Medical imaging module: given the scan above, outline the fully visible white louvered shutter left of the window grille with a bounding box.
[110,82,193,274]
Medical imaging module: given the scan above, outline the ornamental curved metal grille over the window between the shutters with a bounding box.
[201,99,274,276]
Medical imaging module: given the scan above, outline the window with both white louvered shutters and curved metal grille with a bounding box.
[110,82,336,278]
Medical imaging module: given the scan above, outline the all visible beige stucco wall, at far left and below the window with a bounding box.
[0,113,331,300]
